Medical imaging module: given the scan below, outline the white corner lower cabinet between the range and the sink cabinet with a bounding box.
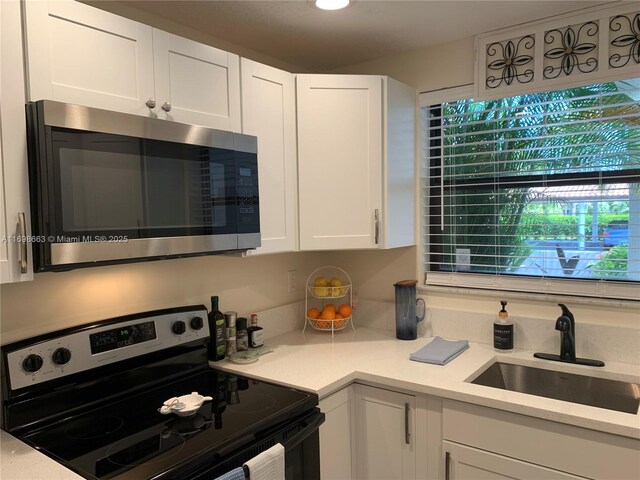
[320,384,430,480]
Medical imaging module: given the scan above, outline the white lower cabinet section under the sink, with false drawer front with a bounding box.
[441,400,640,480]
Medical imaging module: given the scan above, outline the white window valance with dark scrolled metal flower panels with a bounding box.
[475,2,640,100]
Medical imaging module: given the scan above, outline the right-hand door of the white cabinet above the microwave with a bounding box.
[153,29,240,132]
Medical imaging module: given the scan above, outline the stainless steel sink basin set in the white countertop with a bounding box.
[471,362,640,415]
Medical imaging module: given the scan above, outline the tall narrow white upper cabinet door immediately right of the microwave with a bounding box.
[241,58,298,253]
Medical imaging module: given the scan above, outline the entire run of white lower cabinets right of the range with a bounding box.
[320,390,640,480]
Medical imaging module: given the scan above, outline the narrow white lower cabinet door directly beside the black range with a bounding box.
[320,386,357,480]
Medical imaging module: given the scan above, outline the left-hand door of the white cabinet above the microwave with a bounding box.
[25,0,154,115]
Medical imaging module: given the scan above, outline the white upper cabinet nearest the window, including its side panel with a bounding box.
[296,75,416,250]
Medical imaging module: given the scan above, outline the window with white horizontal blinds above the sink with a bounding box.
[423,79,640,299]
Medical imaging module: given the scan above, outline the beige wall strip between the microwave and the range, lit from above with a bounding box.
[0,249,324,343]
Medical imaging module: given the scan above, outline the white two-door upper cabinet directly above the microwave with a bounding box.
[25,0,240,131]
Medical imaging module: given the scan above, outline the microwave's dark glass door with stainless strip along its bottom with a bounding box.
[46,132,238,264]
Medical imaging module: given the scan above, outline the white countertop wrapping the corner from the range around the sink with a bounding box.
[210,327,640,439]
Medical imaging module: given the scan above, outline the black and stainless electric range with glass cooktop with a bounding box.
[2,306,324,480]
